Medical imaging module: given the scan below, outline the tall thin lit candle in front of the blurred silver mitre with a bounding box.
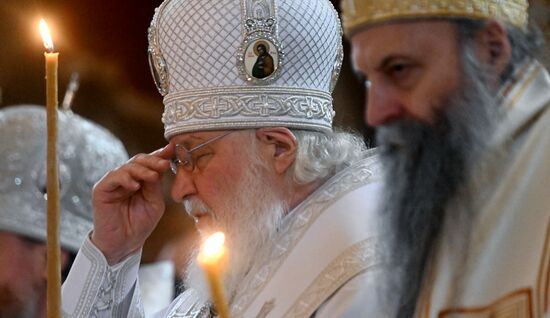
[40,19,61,318]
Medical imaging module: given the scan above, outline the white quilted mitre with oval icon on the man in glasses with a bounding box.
[149,0,343,139]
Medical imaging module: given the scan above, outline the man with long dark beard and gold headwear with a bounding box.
[342,0,550,318]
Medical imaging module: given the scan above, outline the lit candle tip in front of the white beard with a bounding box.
[197,232,229,318]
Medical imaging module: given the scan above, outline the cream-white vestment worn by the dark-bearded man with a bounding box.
[416,62,550,318]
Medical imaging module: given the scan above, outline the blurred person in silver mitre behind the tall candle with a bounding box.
[0,105,128,318]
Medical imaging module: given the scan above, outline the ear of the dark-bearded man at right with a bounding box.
[475,19,512,80]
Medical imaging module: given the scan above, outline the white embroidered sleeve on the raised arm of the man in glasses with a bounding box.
[61,237,144,318]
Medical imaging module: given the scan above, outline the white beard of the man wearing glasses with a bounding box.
[184,158,286,302]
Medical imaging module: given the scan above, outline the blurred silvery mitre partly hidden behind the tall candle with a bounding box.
[0,105,128,252]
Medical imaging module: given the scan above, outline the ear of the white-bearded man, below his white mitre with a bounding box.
[256,127,297,174]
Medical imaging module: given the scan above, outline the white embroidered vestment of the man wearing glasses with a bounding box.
[62,152,382,318]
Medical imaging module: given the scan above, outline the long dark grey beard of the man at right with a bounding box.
[377,43,498,317]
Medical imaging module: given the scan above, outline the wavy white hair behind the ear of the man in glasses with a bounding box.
[291,129,367,184]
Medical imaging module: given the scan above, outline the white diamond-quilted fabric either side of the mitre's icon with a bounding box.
[159,0,341,93]
